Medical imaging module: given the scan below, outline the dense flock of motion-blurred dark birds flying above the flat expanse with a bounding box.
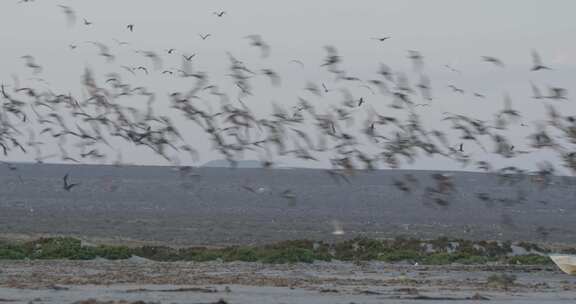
[0,0,576,228]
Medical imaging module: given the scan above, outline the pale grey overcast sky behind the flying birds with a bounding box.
[0,0,576,169]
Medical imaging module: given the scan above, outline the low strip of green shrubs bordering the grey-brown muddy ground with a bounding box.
[0,237,564,265]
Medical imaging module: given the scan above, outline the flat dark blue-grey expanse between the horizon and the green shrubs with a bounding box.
[0,164,576,245]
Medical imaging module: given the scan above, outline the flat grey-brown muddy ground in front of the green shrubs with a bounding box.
[0,258,576,303]
